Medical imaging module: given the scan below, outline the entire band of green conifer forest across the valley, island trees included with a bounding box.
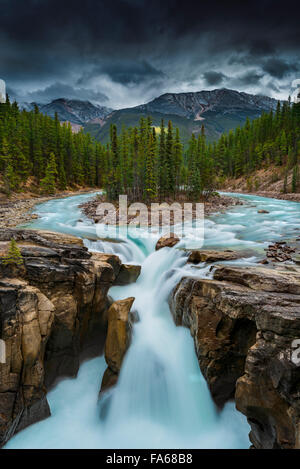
[0,93,300,201]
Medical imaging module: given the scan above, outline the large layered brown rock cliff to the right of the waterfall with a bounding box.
[170,265,300,448]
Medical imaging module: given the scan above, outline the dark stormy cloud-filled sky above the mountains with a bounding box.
[0,0,300,108]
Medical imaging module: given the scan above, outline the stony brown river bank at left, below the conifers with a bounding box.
[0,188,99,228]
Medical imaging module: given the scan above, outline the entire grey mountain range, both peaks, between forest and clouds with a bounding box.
[19,88,277,143]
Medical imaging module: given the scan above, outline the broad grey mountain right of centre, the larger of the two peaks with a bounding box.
[85,88,277,143]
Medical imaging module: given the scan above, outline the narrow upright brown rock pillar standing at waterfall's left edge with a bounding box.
[101,297,134,392]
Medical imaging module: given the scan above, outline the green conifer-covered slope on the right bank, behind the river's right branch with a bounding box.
[213,98,300,192]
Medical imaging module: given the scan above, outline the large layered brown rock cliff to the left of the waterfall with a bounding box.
[0,229,121,446]
